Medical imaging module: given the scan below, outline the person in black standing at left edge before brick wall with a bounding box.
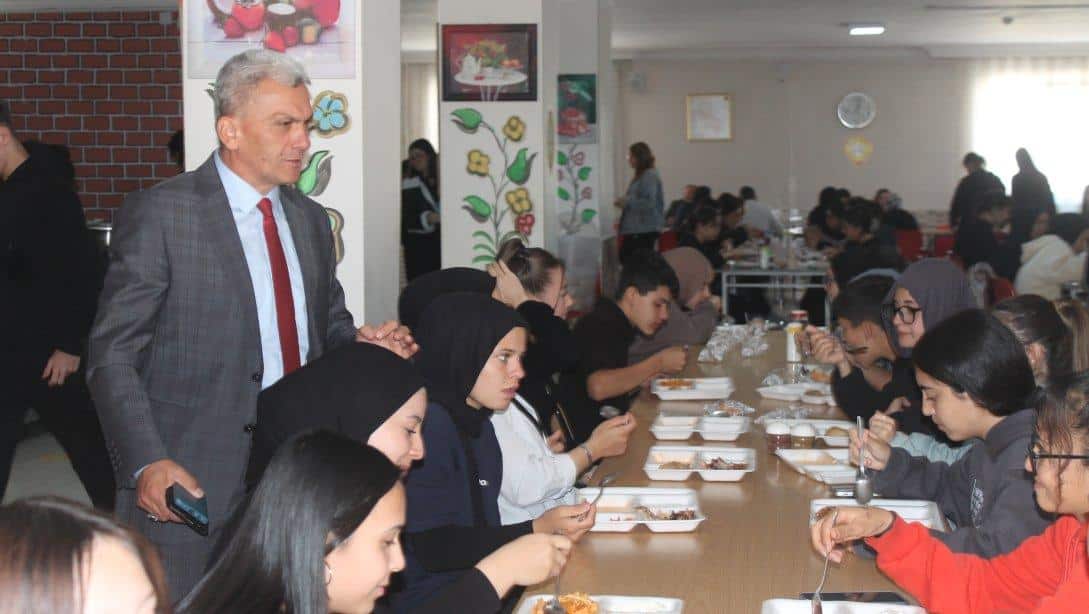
[0,101,114,511]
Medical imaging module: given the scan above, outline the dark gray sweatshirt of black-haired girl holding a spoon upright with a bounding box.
[873,409,1054,558]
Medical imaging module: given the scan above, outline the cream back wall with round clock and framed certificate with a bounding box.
[614,60,987,210]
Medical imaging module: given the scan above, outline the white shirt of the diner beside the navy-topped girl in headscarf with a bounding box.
[491,395,578,525]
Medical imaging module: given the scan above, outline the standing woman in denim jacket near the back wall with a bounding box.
[615,142,665,266]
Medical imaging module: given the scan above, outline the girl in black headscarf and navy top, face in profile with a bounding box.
[391,293,595,611]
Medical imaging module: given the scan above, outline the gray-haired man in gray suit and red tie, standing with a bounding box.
[87,50,416,600]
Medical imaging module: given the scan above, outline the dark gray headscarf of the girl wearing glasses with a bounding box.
[885,258,979,357]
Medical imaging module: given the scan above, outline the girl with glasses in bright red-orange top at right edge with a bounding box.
[811,373,1089,614]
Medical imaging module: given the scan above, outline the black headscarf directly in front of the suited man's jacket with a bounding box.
[246,343,425,486]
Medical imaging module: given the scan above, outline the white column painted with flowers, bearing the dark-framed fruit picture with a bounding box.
[438,0,544,268]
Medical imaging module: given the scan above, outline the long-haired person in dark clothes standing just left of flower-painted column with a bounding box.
[401,138,442,281]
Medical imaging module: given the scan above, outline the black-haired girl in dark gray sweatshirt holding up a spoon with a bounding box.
[851,309,1051,557]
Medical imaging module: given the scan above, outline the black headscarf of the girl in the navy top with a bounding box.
[416,292,528,438]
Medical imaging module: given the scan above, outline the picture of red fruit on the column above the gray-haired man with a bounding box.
[184,0,358,79]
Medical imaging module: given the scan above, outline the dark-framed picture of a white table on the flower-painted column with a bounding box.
[440,24,537,102]
